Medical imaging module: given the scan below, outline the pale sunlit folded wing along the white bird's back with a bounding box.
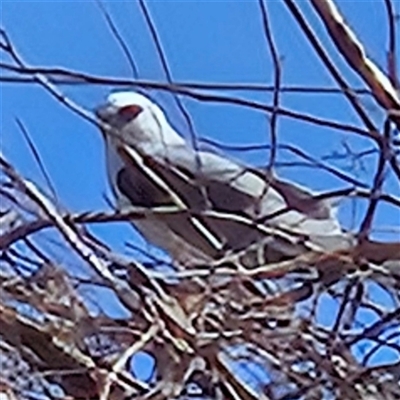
[153,147,340,220]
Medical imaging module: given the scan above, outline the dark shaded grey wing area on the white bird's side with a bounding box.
[116,145,270,258]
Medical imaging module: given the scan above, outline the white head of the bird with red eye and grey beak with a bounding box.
[95,91,182,145]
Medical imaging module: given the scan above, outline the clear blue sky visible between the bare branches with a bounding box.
[1,0,400,380]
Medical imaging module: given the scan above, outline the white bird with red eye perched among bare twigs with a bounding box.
[96,91,347,265]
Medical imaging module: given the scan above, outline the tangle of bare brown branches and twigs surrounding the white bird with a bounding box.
[0,0,400,400]
